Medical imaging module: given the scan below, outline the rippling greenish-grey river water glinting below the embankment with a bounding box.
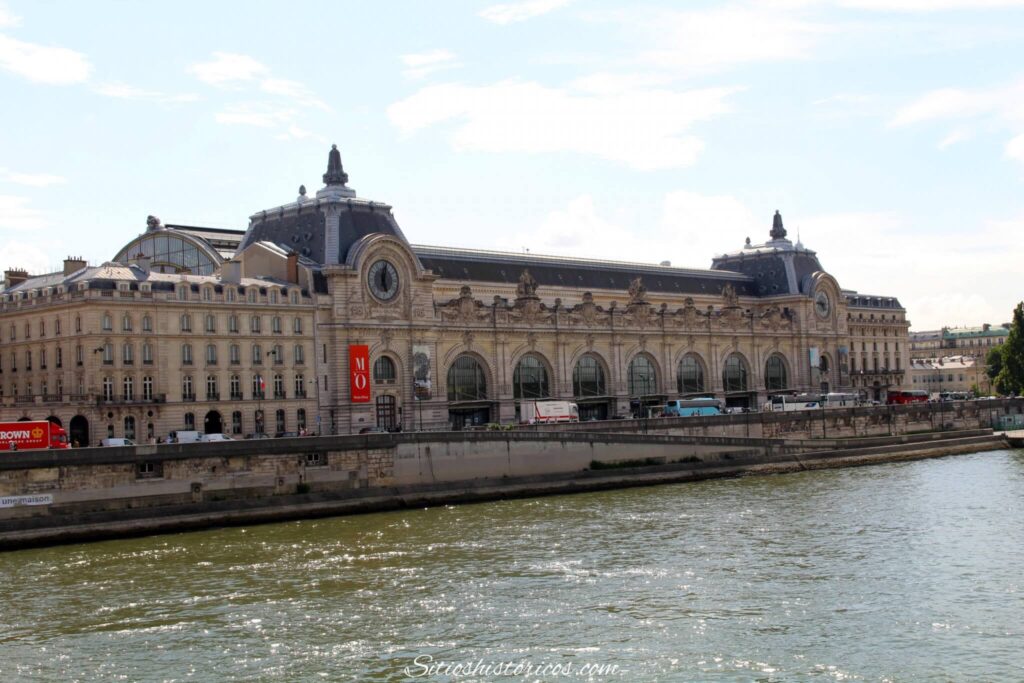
[0,451,1024,681]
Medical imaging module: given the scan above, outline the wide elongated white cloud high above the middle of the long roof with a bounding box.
[387,81,736,170]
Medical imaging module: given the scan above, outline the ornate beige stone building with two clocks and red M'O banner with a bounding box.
[0,148,908,440]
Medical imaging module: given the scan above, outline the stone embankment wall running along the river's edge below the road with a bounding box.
[0,400,1024,547]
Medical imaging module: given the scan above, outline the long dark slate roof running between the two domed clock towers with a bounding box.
[413,245,756,296]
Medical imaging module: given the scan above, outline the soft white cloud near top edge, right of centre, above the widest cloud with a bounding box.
[627,5,835,73]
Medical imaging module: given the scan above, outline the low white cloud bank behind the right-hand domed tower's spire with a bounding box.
[498,190,1024,330]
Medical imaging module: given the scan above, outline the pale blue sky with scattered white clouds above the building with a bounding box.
[0,0,1024,331]
